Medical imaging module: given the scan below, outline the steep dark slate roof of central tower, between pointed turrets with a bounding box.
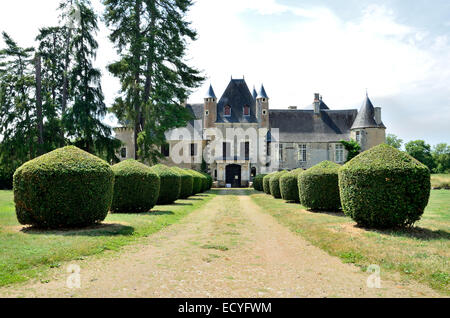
[216,79,257,123]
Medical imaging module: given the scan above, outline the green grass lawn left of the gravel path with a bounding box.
[0,191,215,286]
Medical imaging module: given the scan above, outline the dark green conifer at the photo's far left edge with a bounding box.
[0,32,38,171]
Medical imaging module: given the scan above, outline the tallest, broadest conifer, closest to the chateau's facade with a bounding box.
[103,0,203,162]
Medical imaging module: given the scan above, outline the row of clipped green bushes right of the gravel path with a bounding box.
[254,144,431,228]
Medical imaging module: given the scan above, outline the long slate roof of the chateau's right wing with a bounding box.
[269,109,358,142]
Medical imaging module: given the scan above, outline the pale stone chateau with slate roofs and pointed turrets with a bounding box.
[115,79,386,187]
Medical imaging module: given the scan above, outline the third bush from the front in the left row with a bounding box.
[150,164,181,204]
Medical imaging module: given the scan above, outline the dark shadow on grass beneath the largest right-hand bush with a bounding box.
[355,225,450,241]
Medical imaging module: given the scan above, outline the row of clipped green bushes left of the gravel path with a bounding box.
[13,146,212,229]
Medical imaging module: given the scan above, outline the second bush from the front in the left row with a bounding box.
[111,159,160,213]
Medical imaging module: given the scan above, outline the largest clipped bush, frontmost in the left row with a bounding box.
[13,146,114,229]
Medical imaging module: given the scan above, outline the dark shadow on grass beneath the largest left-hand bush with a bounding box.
[20,223,134,236]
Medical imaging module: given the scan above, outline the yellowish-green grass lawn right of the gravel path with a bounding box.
[251,190,450,295]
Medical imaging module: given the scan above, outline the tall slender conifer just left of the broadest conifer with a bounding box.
[63,1,120,160]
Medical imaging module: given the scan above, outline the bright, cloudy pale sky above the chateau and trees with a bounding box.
[0,0,450,145]
